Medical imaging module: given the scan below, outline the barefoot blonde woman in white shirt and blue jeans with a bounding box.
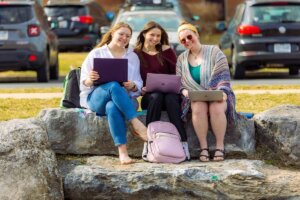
[80,22,147,164]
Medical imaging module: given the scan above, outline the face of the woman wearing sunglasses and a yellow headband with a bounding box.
[179,29,199,49]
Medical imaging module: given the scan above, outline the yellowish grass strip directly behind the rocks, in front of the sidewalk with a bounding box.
[0,94,300,121]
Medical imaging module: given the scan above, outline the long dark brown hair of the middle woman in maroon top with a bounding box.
[135,21,169,67]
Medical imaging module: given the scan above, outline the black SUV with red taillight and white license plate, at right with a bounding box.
[220,0,300,78]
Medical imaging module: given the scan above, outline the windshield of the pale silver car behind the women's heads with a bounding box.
[120,13,180,32]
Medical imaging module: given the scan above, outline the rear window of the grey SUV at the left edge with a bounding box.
[0,5,33,24]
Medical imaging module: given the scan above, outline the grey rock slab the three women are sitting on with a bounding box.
[38,108,255,157]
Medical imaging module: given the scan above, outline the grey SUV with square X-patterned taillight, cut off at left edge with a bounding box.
[0,0,58,82]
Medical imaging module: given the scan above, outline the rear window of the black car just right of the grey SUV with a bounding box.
[45,5,86,18]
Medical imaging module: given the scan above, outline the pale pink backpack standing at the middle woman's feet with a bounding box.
[142,121,186,163]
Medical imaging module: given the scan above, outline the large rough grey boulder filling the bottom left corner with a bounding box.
[0,119,64,200]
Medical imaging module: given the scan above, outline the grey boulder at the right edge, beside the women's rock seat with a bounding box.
[254,105,300,167]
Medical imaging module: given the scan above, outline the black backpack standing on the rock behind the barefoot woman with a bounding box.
[60,67,81,108]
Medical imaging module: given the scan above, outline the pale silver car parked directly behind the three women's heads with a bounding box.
[102,10,185,55]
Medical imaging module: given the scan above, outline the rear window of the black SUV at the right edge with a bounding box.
[250,5,300,23]
